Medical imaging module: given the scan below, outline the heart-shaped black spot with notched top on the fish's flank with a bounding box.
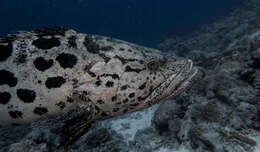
[33,57,53,71]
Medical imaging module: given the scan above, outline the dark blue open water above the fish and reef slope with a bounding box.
[0,0,242,46]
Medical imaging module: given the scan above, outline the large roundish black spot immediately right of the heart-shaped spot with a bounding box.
[56,53,78,69]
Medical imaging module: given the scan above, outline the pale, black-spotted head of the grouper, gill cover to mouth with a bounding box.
[74,42,198,116]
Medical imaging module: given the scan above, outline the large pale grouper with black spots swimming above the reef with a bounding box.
[0,28,198,145]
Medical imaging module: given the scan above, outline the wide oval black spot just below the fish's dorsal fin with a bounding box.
[32,37,61,50]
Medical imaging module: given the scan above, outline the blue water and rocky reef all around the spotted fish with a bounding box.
[3,0,260,152]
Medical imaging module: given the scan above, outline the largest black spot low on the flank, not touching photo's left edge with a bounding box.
[16,89,36,103]
